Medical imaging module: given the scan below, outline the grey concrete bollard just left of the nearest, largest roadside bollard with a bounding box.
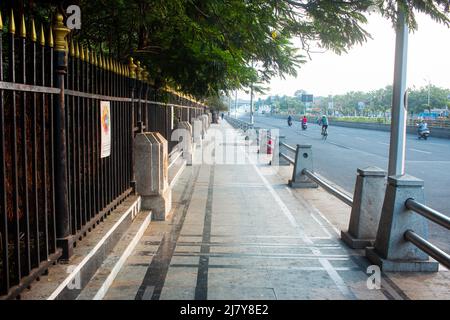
[341,167,386,249]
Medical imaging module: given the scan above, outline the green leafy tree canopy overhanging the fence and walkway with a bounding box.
[1,0,450,98]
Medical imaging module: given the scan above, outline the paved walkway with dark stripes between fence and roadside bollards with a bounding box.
[100,121,450,300]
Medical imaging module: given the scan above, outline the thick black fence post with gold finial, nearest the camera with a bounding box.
[53,14,73,259]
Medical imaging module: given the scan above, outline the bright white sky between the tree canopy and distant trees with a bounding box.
[246,14,450,100]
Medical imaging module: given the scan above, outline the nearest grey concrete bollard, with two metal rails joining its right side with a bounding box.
[366,175,439,272]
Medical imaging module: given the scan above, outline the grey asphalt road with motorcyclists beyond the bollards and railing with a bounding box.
[242,116,450,253]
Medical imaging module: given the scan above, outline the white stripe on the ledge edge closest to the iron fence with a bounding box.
[47,197,141,300]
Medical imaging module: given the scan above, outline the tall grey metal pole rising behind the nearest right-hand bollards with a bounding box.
[388,8,408,176]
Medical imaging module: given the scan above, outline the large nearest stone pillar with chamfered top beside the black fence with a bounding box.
[133,132,172,220]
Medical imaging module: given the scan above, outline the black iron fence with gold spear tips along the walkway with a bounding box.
[0,13,206,298]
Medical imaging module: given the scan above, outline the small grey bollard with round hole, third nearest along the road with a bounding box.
[289,144,318,188]
